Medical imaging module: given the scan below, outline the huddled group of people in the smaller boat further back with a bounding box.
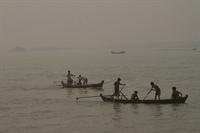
[66,70,88,85]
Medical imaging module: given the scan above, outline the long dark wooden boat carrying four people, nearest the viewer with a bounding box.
[100,94,188,104]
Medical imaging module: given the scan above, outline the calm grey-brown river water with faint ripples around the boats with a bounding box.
[0,45,200,133]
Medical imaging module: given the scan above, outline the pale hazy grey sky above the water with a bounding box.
[0,0,200,49]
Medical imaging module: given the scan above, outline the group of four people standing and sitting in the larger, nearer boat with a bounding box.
[112,78,182,100]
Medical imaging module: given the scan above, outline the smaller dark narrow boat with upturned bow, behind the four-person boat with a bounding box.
[61,80,104,88]
